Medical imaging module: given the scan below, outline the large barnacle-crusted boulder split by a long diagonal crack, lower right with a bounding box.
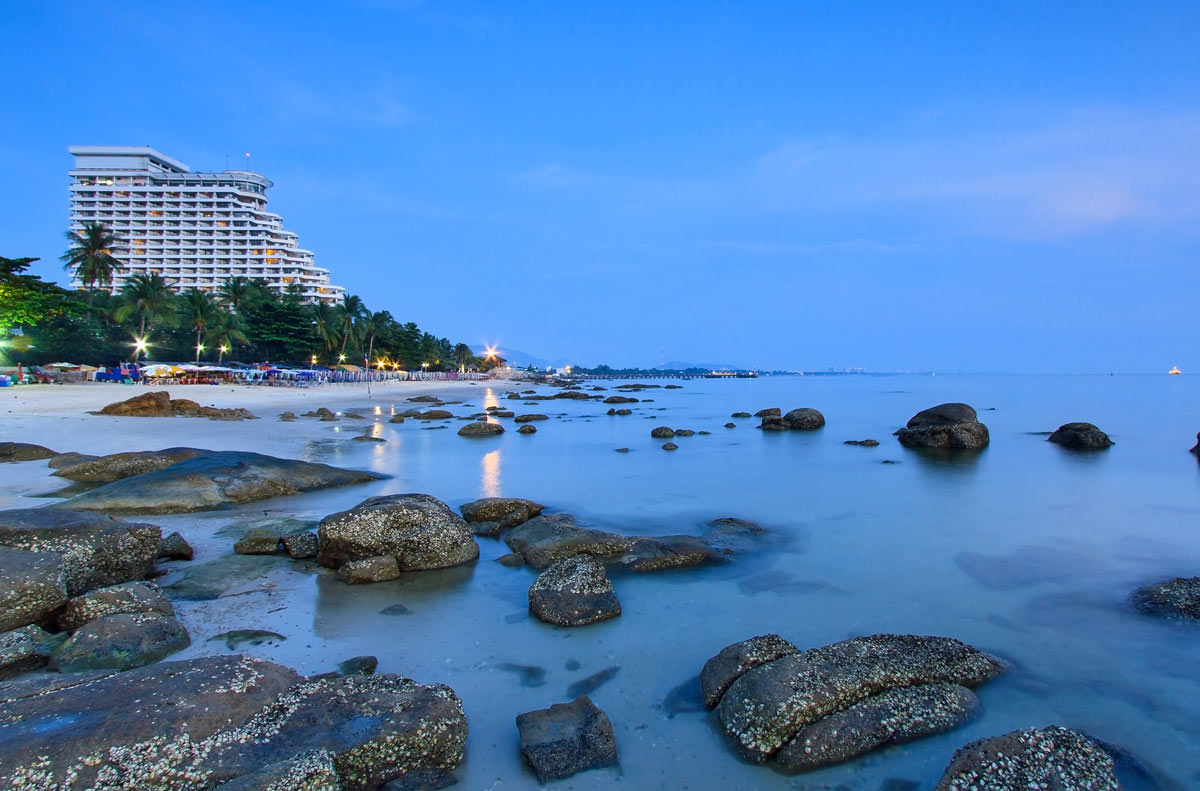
[702,635,1002,771]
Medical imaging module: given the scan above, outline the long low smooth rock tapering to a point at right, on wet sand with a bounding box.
[52,450,380,514]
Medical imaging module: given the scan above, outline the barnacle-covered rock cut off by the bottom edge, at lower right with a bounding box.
[936,725,1121,791]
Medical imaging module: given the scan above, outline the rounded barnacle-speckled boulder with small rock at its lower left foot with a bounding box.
[317,495,479,571]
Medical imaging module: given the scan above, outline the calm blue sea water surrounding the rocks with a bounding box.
[21,376,1200,791]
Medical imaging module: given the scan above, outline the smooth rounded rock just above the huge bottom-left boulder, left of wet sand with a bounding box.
[50,612,191,673]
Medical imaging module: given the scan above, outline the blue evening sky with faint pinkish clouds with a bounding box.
[0,0,1200,373]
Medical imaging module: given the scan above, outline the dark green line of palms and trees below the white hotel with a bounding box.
[0,223,493,371]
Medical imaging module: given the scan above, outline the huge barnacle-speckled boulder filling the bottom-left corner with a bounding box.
[0,655,467,791]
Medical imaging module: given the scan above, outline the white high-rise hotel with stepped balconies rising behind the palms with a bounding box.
[68,145,344,302]
